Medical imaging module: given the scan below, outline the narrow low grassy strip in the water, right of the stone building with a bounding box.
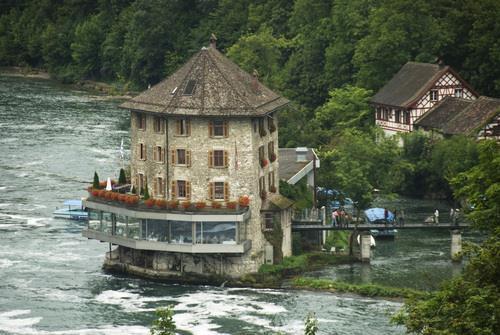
[292,277,428,298]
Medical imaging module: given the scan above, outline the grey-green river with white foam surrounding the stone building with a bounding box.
[0,76,472,335]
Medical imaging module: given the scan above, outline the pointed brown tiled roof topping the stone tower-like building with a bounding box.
[120,46,289,116]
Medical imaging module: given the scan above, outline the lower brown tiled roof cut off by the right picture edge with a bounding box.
[443,96,500,135]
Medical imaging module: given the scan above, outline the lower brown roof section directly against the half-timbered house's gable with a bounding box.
[415,96,473,131]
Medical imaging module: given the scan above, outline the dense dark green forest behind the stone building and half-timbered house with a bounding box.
[0,0,500,201]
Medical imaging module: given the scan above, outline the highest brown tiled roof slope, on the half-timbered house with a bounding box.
[371,62,449,107]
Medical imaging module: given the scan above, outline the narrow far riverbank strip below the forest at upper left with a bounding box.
[0,66,137,100]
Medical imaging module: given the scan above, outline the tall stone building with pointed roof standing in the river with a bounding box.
[83,40,292,277]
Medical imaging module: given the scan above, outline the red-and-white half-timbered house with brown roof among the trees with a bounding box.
[371,62,478,135]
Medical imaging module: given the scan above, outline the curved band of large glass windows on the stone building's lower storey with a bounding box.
[88,209,246,244]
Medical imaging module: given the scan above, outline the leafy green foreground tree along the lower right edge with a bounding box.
[393,140,500,335]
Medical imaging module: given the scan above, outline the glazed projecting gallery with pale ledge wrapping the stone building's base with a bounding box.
[82,198,251,254]
